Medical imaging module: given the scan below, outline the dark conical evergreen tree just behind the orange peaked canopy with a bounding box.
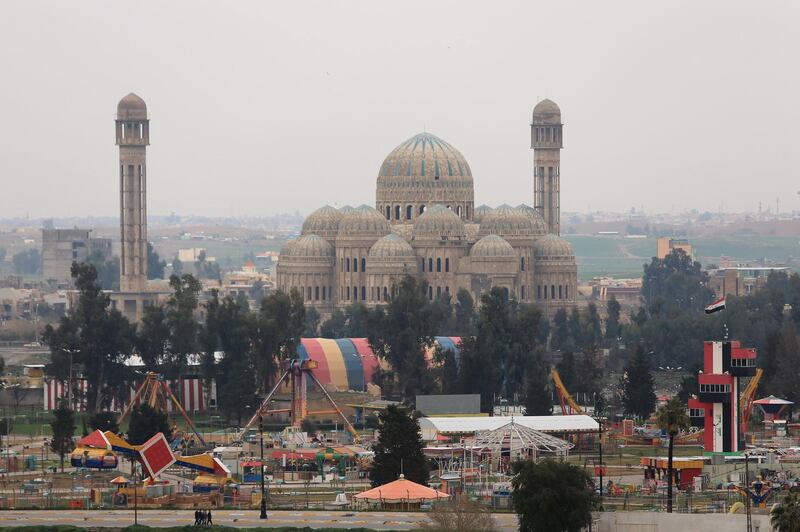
[369,405,430,486]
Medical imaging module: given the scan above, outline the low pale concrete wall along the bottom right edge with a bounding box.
[595,512,772,532]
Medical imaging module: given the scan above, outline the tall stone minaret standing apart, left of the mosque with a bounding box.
[116,93,150,292]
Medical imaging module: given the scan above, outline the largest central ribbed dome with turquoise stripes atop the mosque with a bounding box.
[376,133,474,223]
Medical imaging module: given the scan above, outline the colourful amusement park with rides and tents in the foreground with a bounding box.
[0,330,800,532]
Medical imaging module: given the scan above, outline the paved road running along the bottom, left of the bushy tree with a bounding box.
[0,510,517,532]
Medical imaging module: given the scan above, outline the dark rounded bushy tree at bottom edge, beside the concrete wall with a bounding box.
[511,460,595,532]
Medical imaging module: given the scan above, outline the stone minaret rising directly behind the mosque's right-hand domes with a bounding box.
[531,100,564,235]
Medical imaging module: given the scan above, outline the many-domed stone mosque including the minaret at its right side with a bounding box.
[276,100,578,316]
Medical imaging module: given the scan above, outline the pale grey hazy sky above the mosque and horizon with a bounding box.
[0,0,800,218]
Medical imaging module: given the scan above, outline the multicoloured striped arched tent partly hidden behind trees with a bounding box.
[297,336,461,392]
